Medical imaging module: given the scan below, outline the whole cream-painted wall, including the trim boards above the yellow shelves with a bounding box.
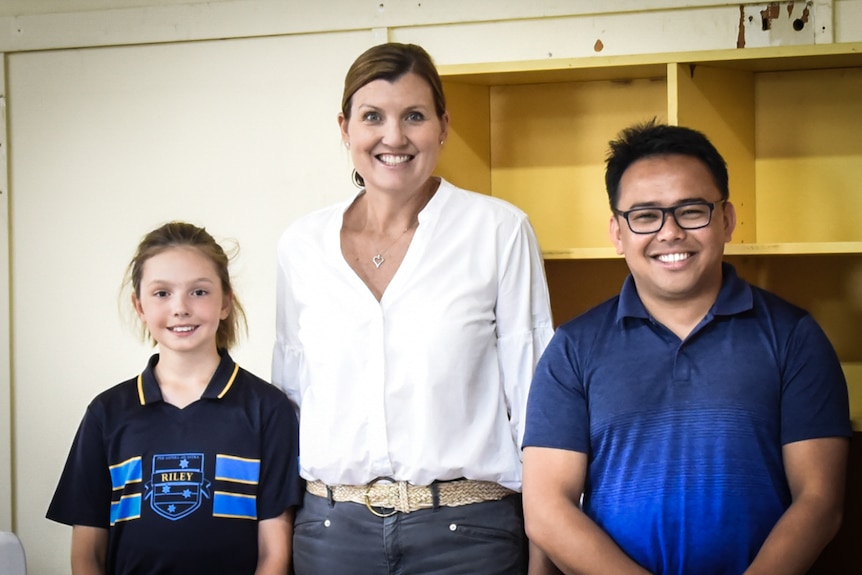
[0,0,862,575]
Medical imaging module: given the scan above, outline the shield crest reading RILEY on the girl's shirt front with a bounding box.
[144,453,210,521]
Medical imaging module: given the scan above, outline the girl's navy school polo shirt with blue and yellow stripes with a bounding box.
[47,352,301,574]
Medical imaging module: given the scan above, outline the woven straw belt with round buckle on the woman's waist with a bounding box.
[306,479,515,517]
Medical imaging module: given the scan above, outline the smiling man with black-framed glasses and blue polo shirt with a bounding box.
[523,122,852,575]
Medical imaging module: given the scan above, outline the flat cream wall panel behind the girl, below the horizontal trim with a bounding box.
[8,32,371,573]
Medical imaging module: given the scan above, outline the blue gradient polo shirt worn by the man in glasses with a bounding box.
[523,264,852,575]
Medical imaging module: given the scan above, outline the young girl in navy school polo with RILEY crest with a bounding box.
[47,222,300,575]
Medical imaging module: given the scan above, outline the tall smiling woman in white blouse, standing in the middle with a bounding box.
[272,43,553,575]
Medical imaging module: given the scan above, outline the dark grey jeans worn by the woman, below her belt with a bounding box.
[293,493,527,575]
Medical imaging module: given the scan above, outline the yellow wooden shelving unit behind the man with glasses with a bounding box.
[439,43,862,431]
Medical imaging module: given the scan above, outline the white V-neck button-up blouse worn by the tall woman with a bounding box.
[272,180,553,491]
